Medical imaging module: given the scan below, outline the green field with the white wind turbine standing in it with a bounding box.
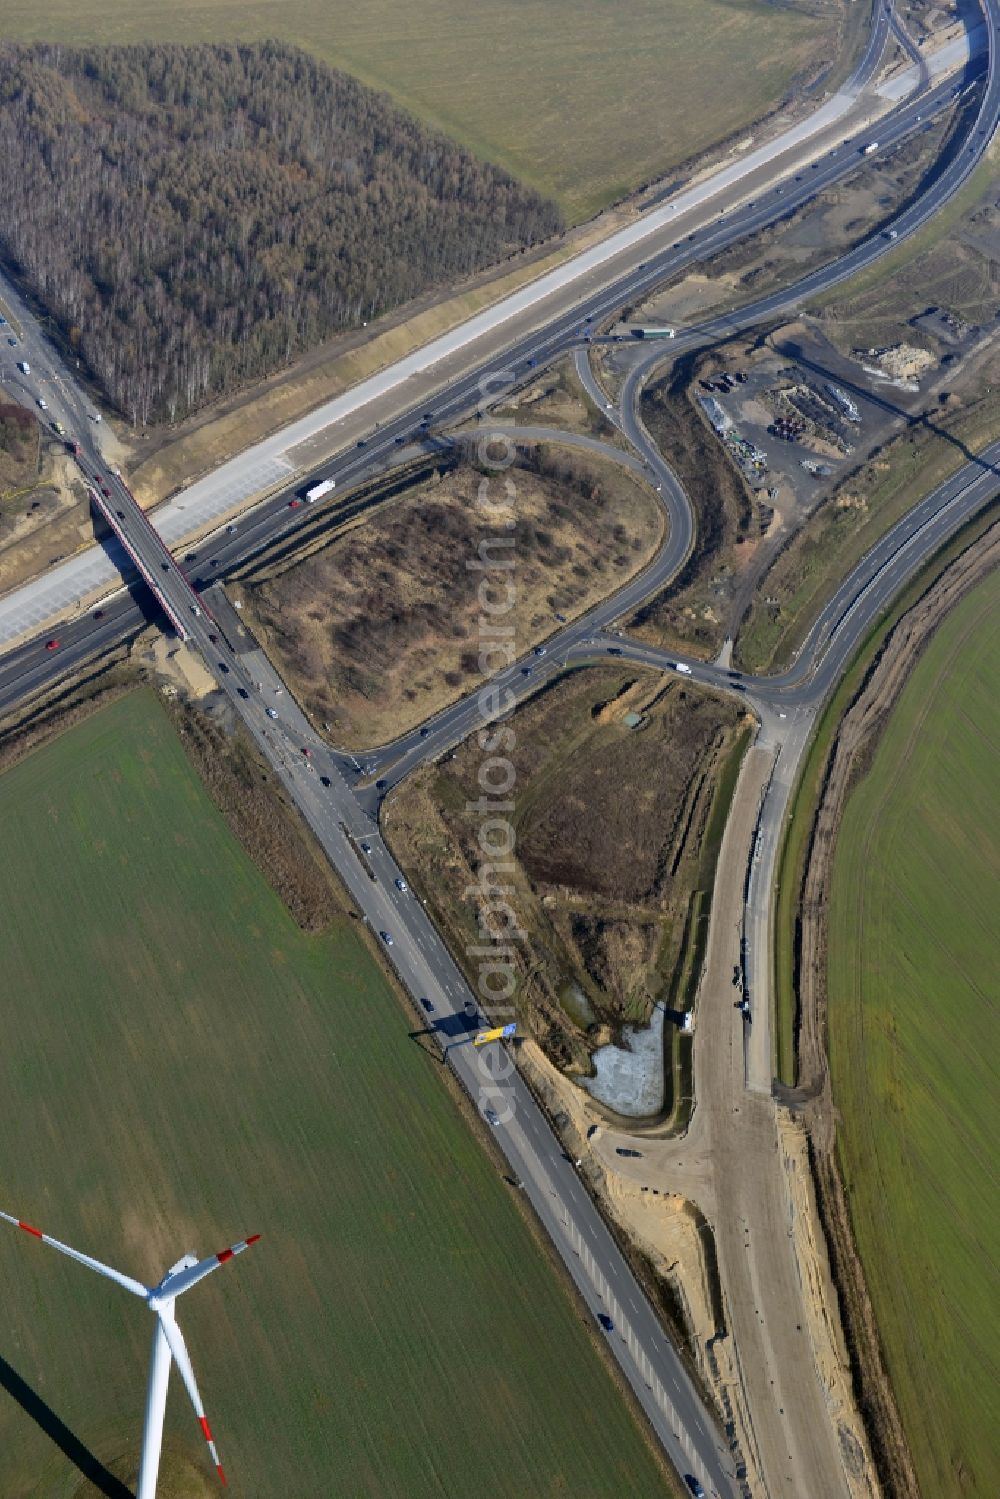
[0,693,677,1499]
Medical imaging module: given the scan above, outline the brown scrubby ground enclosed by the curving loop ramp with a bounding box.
[244,448,664,747]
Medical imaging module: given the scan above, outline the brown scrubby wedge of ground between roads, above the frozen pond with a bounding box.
[385,667,742,1070]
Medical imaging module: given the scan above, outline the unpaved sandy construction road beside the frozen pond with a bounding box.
[592,736,879,1499]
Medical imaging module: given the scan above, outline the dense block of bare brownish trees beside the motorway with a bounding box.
[0,42,559,426]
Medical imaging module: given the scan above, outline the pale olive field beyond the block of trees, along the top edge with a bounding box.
[0,0,839,220]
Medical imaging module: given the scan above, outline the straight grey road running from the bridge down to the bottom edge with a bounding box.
[195,589,739,1496]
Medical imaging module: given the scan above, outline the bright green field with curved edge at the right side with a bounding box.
[829,573,1000,1499]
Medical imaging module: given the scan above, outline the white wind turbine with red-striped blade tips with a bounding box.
[0,1211,261,1499]
